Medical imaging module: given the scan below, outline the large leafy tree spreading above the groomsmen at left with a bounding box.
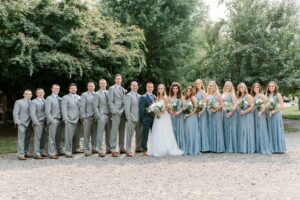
[0,0,145,95]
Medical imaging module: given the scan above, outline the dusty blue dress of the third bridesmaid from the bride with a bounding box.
[196,92,210,152]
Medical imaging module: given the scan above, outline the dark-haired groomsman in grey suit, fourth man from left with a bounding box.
[61,83,80,158]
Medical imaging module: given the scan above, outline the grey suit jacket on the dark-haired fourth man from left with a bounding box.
[61,94,80,124]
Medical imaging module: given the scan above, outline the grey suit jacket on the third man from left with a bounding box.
[45,94,61,123]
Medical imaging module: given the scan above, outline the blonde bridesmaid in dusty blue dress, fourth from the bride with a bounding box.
[207,81,225,153]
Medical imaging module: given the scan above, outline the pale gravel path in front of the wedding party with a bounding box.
[0,133,300,200]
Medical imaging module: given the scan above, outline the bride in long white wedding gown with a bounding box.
[148,84,183,157]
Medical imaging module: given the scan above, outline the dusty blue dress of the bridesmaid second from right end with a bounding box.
[253,96,272,154]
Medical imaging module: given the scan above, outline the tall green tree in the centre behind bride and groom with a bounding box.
[100,0,206,88]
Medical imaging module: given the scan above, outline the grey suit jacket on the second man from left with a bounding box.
[30,98,46,125]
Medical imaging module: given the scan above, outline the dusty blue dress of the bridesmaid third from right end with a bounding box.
[238,96,255,153]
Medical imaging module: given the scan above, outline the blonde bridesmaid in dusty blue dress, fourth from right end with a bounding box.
[222,81,238,153]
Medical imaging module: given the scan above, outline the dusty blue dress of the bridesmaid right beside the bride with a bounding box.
[170,97,187,152]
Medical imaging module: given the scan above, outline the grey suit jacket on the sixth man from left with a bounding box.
[93,90,110,119]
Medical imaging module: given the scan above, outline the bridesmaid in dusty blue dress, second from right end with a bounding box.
[251,83,272,154]
